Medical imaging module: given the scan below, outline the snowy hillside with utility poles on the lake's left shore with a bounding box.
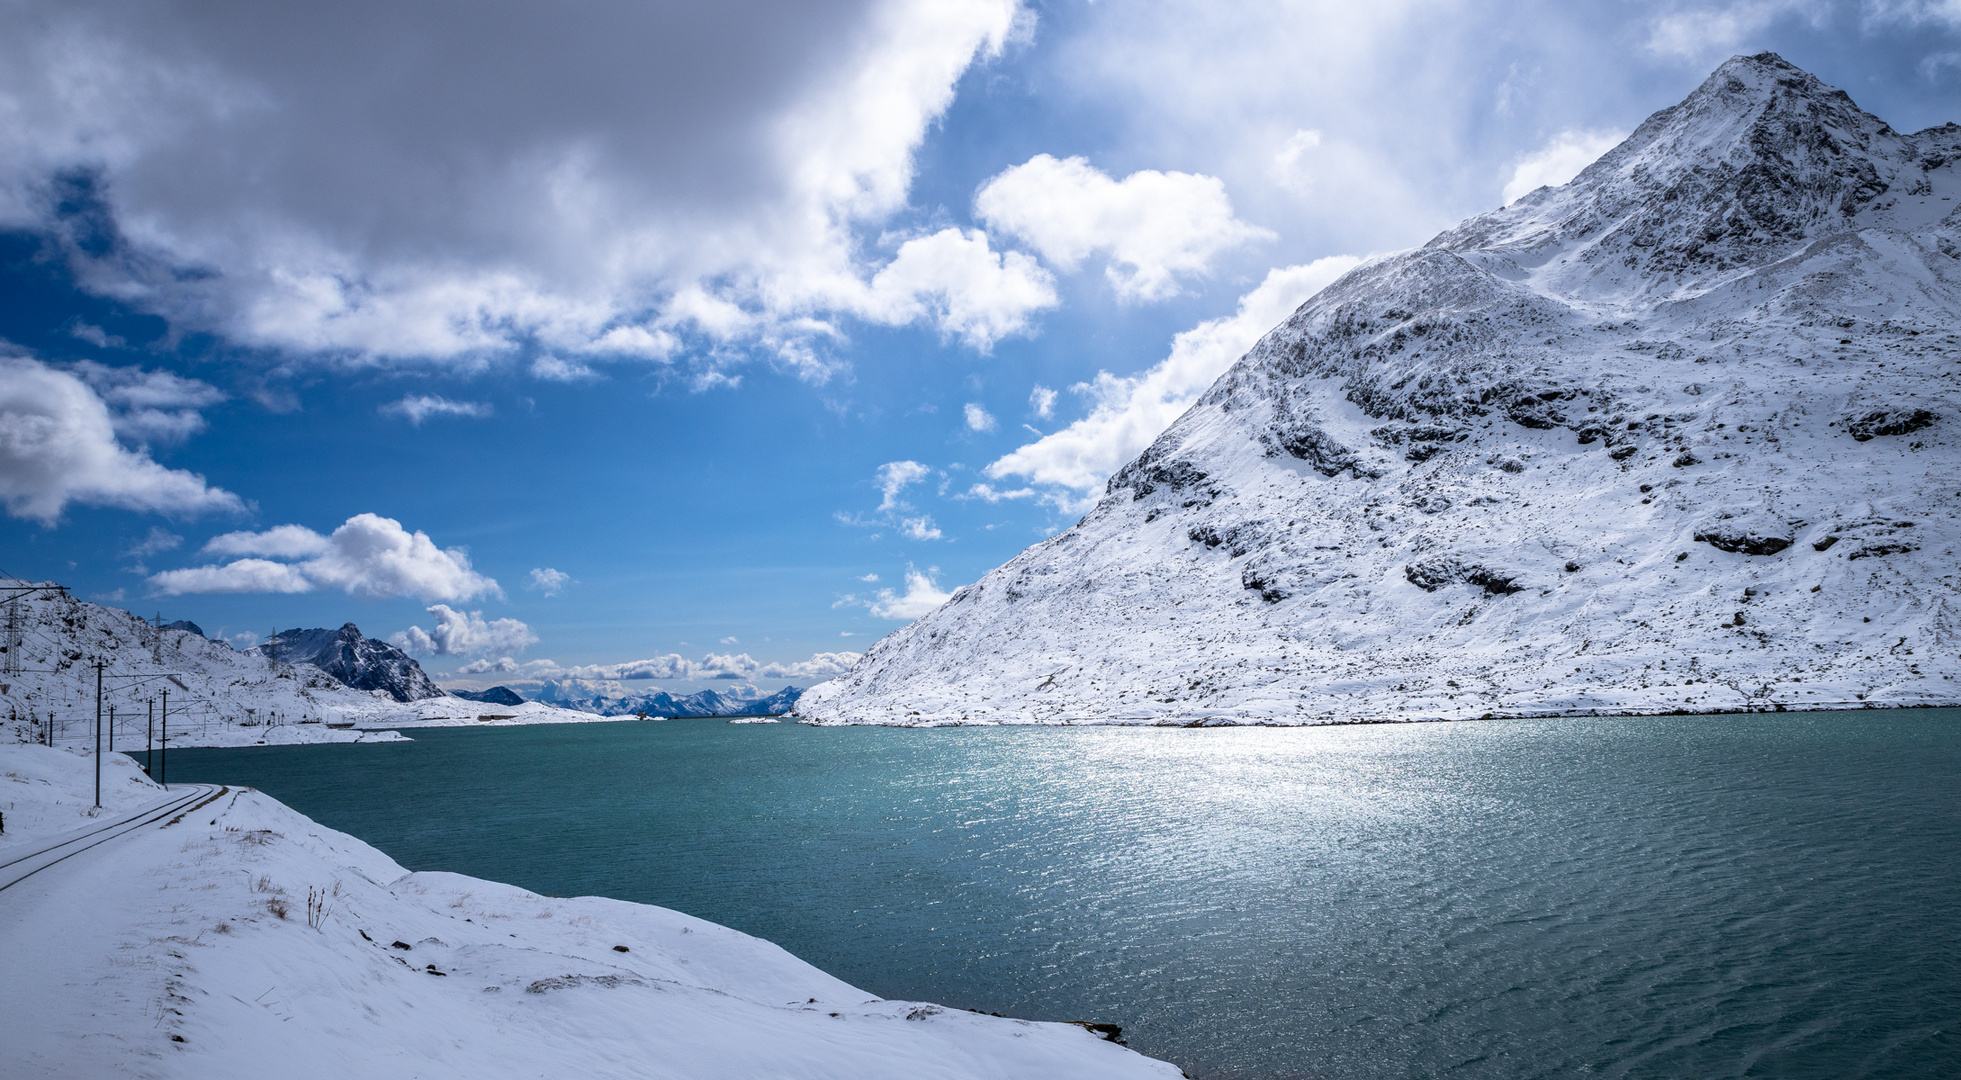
[0,578,427,749]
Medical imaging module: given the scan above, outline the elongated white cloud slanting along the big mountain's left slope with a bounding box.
[988,255,1361,512]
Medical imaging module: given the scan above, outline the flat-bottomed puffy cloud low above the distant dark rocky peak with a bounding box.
[149,514,502,602]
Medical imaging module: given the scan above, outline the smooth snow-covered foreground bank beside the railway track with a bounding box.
[0,743,1181,1080]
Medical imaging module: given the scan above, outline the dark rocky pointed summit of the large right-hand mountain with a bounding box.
[1428,53,1945,302]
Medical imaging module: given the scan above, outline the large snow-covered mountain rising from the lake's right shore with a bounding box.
[796,53,1961,723]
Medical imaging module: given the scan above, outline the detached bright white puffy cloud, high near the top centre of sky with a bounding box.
[975,153,1273,300]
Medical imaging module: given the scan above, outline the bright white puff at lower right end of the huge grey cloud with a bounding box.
[855,229,1055,351]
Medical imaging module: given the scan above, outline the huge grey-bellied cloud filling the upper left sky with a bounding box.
[0,0,1053,378]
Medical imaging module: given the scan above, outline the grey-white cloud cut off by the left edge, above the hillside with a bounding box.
[0,357,245,525]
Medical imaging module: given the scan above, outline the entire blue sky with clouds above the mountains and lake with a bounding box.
[0,0,1961,690]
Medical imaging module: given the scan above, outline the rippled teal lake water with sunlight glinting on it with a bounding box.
[171,710,1961,1080]
